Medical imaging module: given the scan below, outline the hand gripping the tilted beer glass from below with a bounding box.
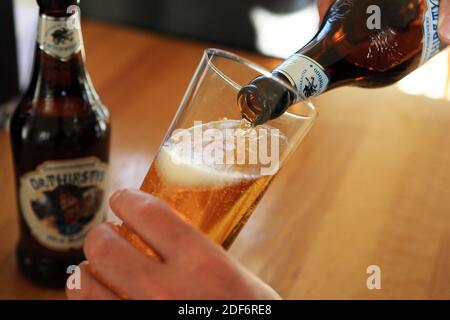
[66,190,280,300]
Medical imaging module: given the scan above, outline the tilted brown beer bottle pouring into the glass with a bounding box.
[239,0,444,125]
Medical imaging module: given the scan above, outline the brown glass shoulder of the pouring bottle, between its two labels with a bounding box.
[299,0,425,89]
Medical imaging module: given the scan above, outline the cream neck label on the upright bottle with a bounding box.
[37,15,83,61]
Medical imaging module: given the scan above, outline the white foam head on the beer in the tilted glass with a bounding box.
[157,120,287,186]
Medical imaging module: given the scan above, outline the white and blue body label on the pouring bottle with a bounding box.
[420,0,441,65]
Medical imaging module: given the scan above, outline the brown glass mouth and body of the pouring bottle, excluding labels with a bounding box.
[238,0,445,125]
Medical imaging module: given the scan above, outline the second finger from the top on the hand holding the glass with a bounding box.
[84,224,163,299]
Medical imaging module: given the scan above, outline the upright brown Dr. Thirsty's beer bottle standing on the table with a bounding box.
[10,0,110,287]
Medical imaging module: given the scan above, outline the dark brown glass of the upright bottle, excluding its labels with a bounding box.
[10,29,110,288]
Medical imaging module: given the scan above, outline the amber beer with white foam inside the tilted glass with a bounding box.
[142,120,288,247]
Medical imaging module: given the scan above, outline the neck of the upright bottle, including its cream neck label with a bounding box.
[29,12,93,98]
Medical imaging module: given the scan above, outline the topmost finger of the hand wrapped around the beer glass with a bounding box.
[110,190,207,260]
